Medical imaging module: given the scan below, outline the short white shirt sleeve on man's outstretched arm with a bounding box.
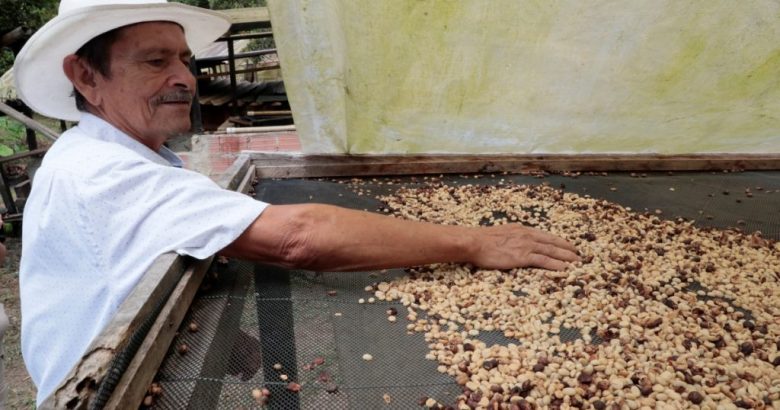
[80,161,268,261]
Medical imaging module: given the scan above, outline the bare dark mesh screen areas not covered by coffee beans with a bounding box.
[155,172,780,409]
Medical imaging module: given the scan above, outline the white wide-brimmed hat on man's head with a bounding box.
[14,0,230,121]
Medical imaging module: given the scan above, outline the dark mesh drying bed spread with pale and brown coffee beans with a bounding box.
[148,172,780,409]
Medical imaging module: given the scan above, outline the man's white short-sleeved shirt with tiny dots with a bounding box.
[19,114,267,404]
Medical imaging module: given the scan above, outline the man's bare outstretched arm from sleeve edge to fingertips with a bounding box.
[222,204,578,271]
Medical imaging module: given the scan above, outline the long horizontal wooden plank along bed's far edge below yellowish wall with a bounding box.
[249,153,780,178]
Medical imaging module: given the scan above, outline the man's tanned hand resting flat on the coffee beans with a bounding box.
[470,224,579,270]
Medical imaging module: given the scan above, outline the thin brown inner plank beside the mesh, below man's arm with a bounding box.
[105,256,213,409]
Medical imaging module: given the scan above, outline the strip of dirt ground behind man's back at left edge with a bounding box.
[0,237,36,409]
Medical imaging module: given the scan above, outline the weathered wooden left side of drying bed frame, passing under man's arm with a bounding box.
[40,157,255,409]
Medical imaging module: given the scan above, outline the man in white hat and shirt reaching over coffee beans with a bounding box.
[10,0,577,403]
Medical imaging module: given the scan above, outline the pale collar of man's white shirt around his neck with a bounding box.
[78,112,184,168]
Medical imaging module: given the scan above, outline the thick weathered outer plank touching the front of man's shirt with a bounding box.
[41,253,184,409]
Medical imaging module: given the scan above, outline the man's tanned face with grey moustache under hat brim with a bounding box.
[95,22,195,150]
